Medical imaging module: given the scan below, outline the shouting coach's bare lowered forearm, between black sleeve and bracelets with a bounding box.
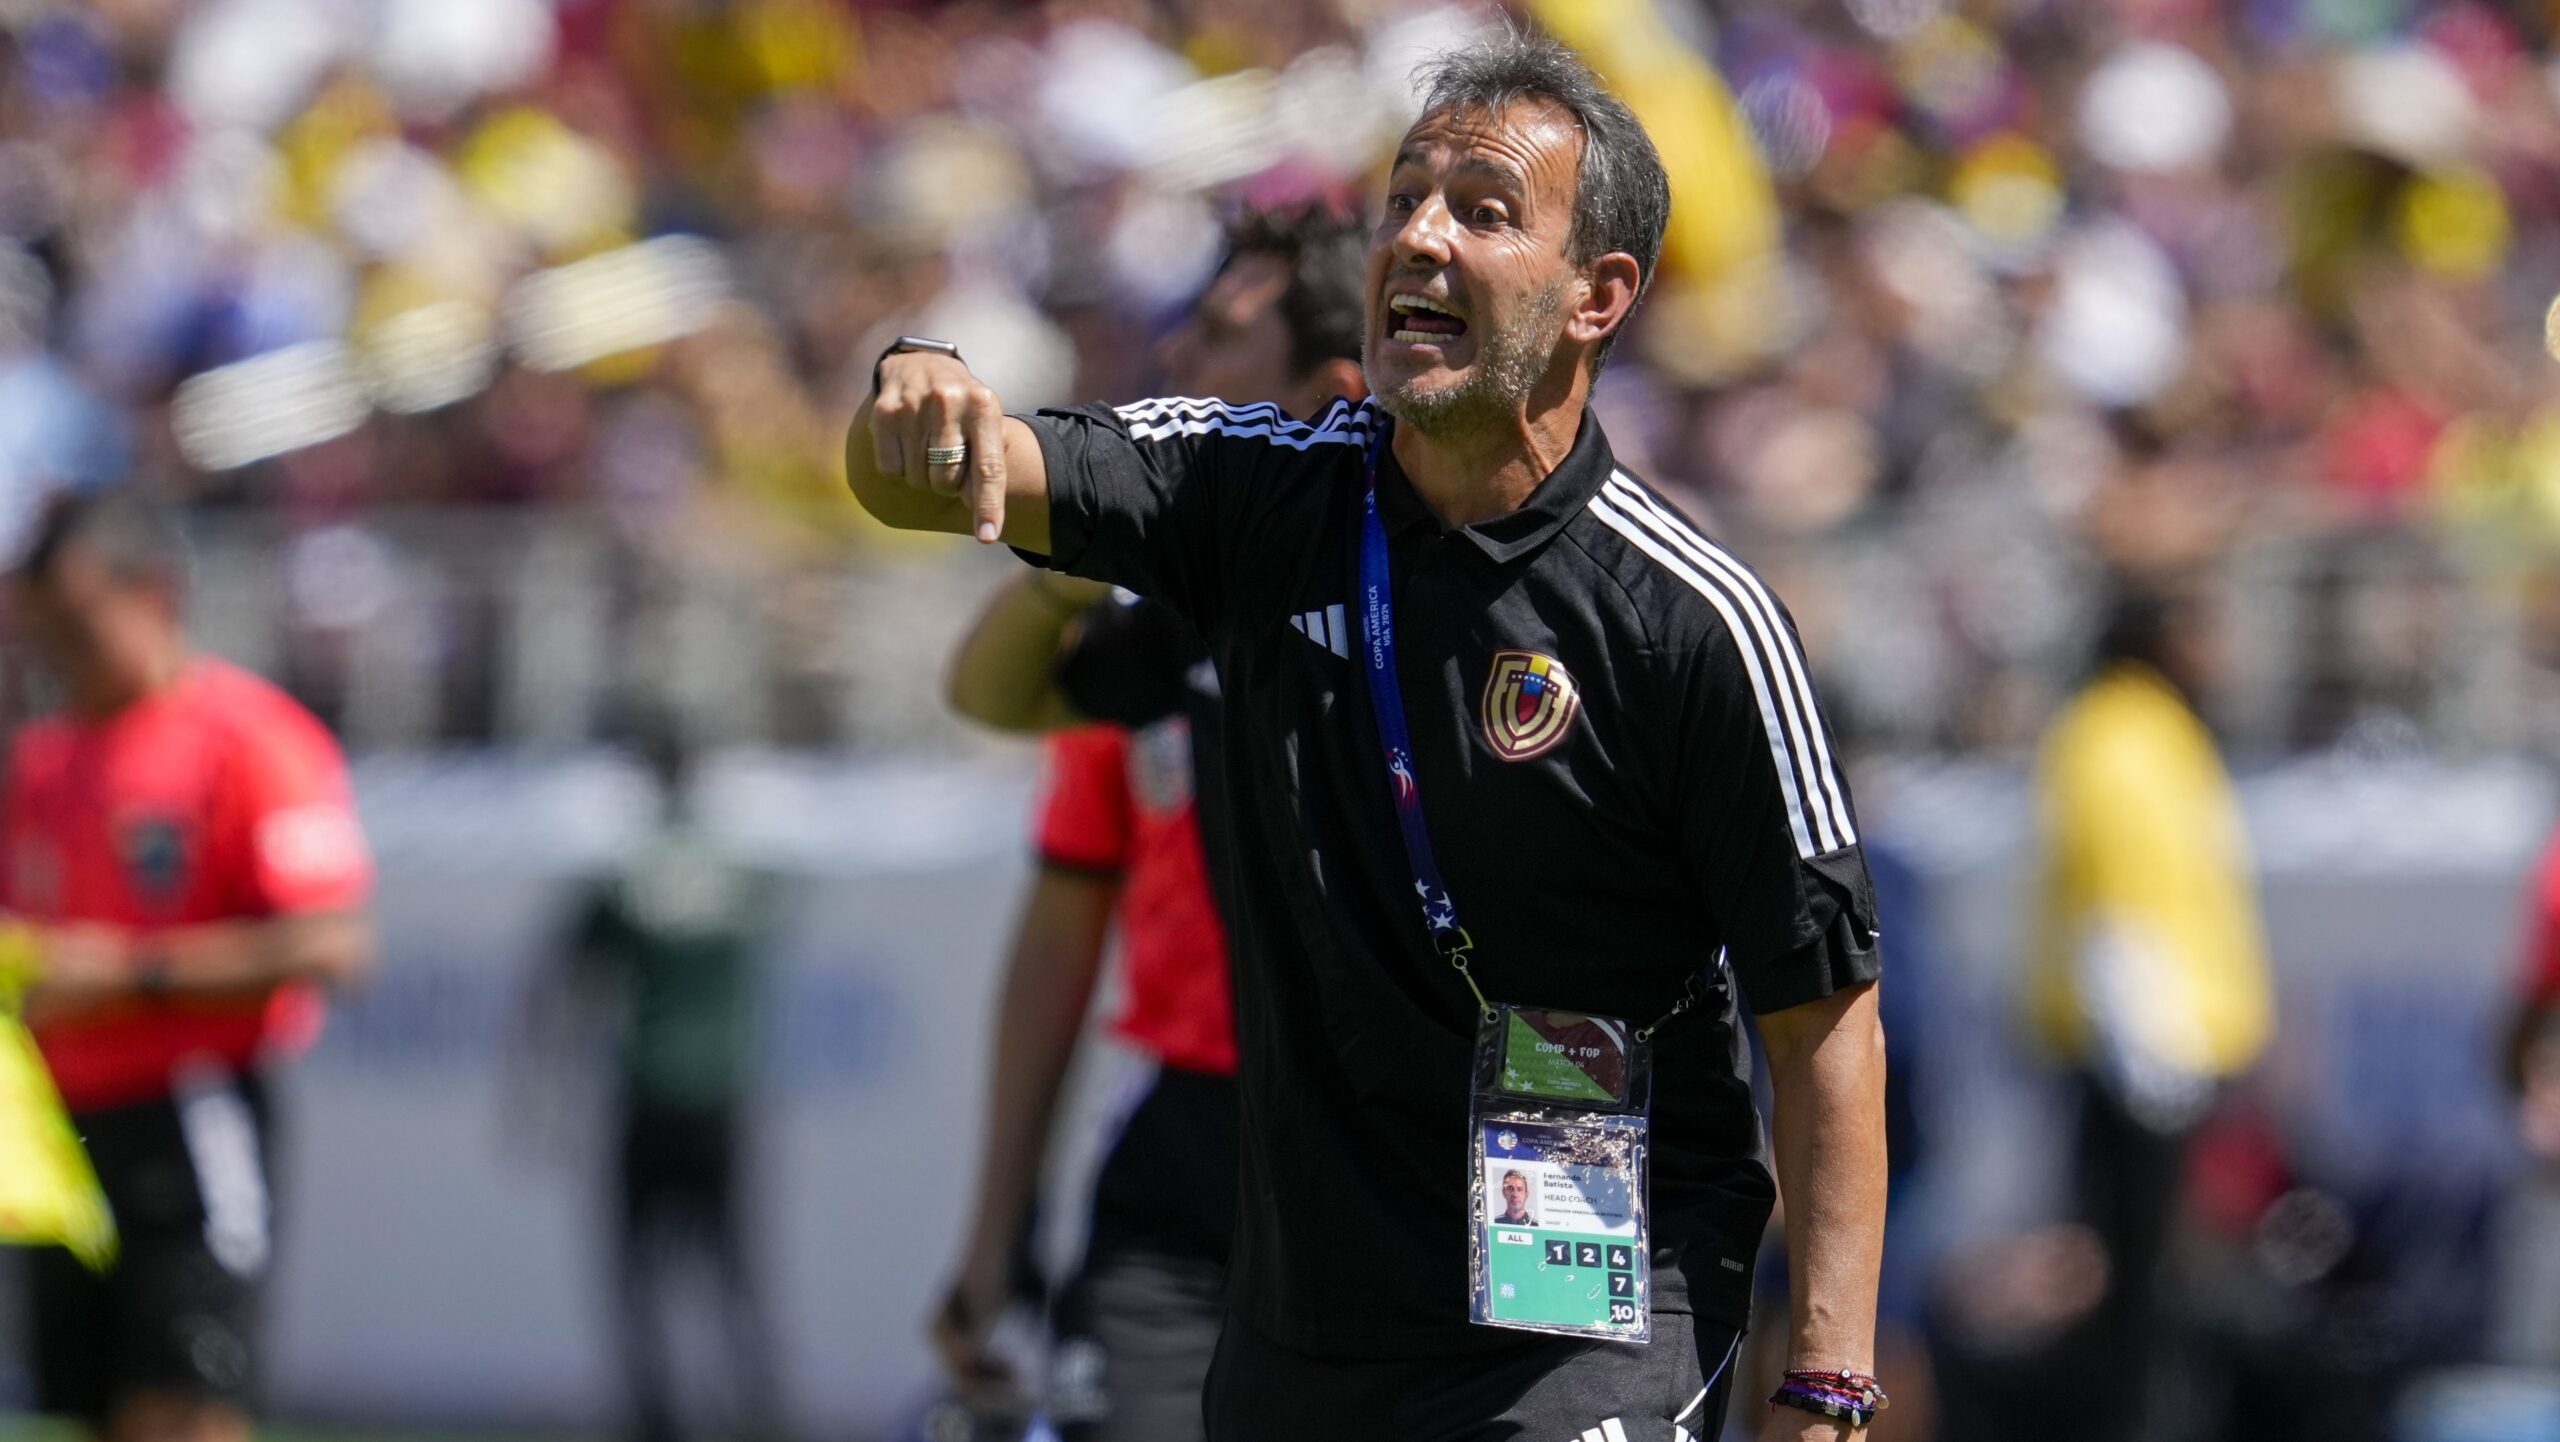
[1761,986,1884,1373]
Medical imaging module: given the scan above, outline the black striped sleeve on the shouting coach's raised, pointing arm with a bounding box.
[1021,400,1370,635]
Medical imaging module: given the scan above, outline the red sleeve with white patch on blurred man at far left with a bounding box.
[233,715,374,917]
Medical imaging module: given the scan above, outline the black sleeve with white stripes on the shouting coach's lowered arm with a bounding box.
[1674,609,1882,1014]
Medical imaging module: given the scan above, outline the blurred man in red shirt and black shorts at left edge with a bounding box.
[0,492,371,1442]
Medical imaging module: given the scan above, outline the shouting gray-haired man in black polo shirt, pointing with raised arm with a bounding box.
[845,33,1884,1442]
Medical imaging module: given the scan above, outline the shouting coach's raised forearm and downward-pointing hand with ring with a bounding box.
[845,351,1050,556]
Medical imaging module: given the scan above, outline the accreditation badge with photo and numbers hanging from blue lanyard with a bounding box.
[1467,1007,1654,1342]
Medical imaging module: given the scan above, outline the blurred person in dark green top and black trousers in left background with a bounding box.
[540,720,783,1442]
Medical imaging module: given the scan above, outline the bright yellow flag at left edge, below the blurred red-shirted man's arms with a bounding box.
[0,927,115,1270]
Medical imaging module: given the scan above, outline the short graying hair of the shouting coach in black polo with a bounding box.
[1421,26,1672,371]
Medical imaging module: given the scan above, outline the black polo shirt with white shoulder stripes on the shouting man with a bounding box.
[1029,400,1879,1357]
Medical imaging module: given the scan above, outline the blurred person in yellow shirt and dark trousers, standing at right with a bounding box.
[2025,587,2276,1442]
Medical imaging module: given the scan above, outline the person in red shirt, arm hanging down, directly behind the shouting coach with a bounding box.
[937,717,1236,1439]
